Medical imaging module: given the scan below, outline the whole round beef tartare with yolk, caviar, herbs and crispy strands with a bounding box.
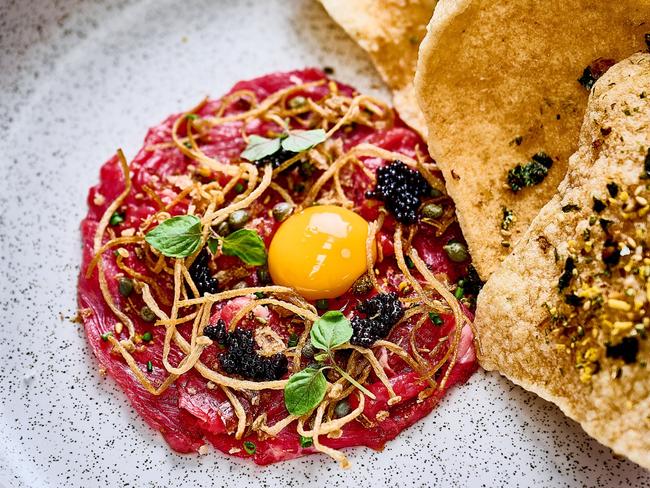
[78,69,481,466]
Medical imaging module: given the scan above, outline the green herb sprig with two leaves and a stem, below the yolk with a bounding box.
[284,310,376,416]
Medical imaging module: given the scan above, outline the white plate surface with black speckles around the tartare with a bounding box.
[0,0,650,488]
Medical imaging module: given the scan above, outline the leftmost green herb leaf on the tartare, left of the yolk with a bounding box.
[145,215,201,258]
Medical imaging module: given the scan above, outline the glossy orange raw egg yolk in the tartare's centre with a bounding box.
[268,205,375,300]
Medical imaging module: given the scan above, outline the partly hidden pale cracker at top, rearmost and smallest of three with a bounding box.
[320,0,437,135]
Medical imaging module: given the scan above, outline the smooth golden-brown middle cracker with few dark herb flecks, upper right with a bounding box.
[415,0,650,279]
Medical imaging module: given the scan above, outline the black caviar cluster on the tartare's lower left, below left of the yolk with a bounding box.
[203,319,288,381]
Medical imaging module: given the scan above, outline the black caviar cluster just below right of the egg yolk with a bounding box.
[350,292,404,347]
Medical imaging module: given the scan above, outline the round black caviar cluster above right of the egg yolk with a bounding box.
[366,161,431,225]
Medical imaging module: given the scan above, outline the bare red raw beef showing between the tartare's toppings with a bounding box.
[78,69,477,464]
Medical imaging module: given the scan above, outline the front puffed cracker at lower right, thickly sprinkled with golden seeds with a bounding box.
[475,54,650,468]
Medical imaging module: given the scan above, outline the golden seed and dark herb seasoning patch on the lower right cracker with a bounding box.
[547,175,650,383]
